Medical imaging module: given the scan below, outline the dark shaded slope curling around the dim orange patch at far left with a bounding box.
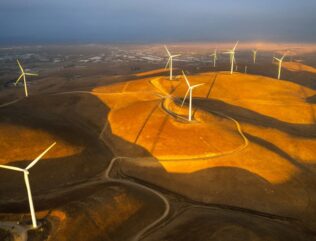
[0,90,150,212]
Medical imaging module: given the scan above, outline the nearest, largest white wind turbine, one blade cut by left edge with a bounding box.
[0,142,56,228]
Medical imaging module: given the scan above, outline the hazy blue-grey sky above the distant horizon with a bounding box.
[0,0,316,44]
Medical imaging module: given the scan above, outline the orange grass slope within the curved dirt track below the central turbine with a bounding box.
[95,76,243,159]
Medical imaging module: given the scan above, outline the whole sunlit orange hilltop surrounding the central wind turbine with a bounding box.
[94,66,316,183]
